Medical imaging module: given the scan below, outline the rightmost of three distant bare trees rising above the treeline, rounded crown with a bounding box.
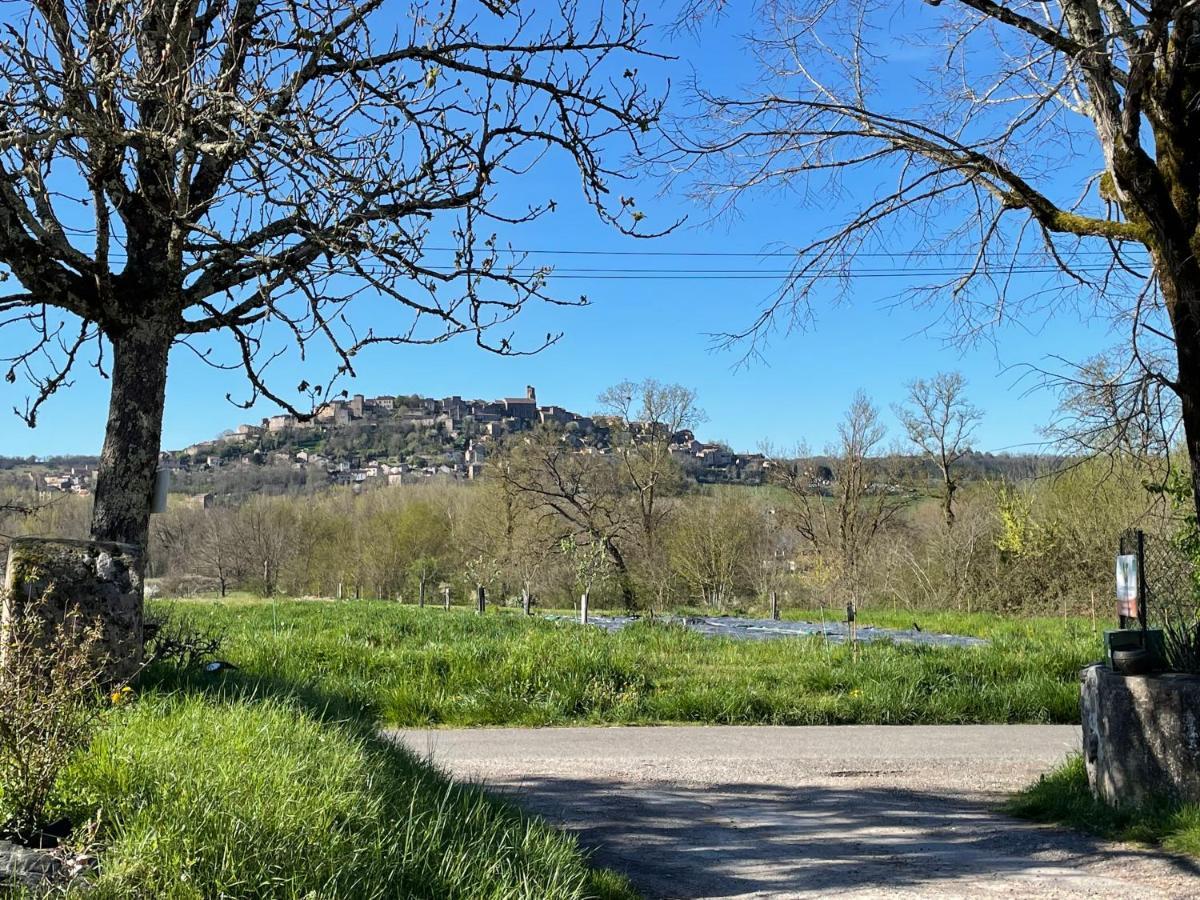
[895,372,983,528]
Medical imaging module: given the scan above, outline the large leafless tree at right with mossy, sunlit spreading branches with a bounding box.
[667,0,1200,518]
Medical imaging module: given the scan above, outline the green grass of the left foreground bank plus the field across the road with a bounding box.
[32,598,1098,900]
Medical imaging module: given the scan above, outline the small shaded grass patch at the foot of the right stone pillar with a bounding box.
[1007,756,1200,856]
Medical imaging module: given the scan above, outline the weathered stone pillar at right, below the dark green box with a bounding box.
[1080,665,1200,806]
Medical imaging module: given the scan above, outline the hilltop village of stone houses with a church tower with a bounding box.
[167,386,763,485]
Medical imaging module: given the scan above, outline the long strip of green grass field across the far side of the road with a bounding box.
[152,600,1099,726]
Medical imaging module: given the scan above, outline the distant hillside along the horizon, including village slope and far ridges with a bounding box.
[0,386,1062,497]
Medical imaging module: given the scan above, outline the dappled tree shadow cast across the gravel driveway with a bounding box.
[475,776,1200,900]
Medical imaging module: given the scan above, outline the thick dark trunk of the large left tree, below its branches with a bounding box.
[91,324,173,549]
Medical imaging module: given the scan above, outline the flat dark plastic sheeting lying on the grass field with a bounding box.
[547,616,988,647]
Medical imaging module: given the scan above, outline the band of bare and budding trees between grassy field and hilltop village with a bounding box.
[100,374,1171,611]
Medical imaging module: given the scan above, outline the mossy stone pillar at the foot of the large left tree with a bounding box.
[0,538,143,683]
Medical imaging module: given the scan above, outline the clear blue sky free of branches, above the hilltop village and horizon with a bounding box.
[0,6,1117,456]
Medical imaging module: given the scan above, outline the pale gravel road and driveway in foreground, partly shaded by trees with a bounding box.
[388,726,1200,900]
